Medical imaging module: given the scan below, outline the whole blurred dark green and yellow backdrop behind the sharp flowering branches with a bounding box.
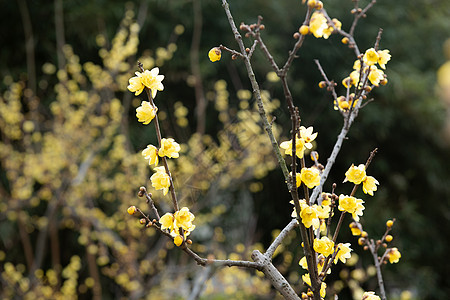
[0,0,450,299]
